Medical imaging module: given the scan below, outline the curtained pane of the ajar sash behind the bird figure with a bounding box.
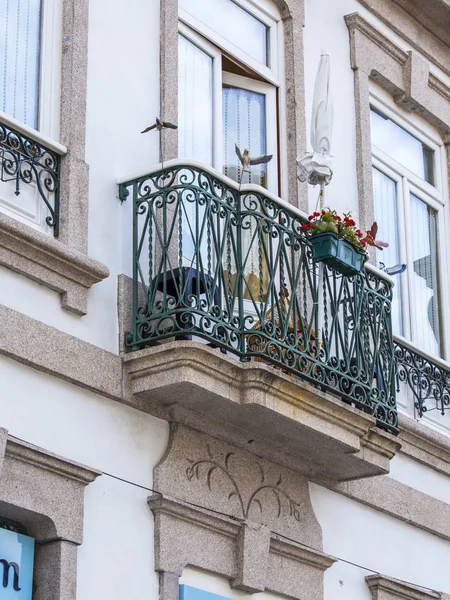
[223,87,267,187]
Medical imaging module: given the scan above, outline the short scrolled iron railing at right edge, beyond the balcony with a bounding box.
[394,341,450,417]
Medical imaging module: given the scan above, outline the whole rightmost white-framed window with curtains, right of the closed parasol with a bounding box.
[370,93,447,364]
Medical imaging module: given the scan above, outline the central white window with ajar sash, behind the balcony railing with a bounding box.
[178,0,281,194]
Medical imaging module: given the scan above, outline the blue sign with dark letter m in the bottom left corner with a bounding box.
[0,528,34,600]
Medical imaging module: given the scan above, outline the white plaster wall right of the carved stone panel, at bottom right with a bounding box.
[309,483,450,600]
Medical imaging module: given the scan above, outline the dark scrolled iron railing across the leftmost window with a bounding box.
[0,123,61,237]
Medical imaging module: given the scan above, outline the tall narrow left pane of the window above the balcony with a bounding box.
[178,35,213,165]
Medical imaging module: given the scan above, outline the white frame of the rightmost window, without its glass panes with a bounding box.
[370,84,450,435]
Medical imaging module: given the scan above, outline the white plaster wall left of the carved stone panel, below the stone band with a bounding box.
[0,358,168,600]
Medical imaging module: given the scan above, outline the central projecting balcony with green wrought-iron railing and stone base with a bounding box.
[119,160,397,479]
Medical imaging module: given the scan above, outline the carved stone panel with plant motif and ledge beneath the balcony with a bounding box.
[149,425,335,600]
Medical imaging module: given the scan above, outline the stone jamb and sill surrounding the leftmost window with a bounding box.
[0,0,109,315]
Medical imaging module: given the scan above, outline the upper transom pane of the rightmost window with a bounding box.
[370,108,435,185]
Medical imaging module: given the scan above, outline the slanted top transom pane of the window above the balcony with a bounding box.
[179,0,269,65]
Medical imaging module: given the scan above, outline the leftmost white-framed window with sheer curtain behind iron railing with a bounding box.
[0,0,62,233]
